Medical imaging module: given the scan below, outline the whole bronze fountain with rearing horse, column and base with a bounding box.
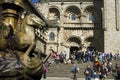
[0,0,46,80]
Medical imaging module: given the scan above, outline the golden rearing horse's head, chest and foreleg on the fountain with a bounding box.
[16,14,46,56]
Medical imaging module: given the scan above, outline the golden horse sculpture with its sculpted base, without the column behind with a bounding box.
[0,14,46,80]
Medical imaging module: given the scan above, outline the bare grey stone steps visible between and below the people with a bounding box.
[47,60,120,79]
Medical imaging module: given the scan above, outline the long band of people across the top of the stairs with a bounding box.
[49,50,120,64]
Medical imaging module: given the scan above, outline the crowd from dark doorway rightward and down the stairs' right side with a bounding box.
[73,51,120,80]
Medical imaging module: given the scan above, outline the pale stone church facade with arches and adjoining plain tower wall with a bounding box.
[31,0,120,57]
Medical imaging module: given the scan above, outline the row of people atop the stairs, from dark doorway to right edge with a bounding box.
[70,50,114,62]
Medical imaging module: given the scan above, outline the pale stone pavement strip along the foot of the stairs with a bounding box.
[41,77,114,80]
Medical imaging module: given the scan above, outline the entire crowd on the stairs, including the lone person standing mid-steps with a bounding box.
[42,50,120,80]
